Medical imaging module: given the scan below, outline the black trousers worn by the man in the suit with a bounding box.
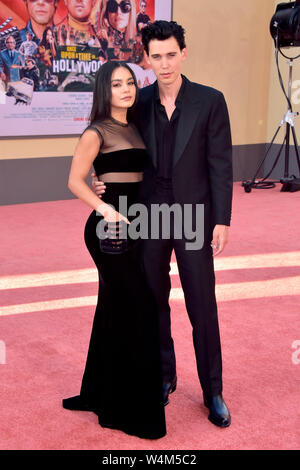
[143,182,222,395]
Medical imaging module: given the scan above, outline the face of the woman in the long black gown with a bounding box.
[111,67,136,110]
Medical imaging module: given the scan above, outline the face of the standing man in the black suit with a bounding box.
[148,36,186,85]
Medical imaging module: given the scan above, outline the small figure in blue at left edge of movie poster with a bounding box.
[0,36,22,83]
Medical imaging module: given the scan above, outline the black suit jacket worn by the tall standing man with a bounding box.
[132,76,233,225]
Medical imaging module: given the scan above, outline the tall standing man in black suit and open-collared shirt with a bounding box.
[94,21,232,427]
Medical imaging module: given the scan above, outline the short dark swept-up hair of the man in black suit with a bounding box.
[142,20,186,55]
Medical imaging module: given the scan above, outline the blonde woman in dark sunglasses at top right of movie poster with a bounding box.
[99,0,136,48]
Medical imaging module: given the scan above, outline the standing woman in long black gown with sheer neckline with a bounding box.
[63,62,166,439]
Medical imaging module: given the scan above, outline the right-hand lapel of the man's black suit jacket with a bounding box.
[173,79,199,168]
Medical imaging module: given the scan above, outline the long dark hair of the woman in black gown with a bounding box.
[90,61,138,124]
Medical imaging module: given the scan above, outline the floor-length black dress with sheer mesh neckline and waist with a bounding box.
[63,119,166,439]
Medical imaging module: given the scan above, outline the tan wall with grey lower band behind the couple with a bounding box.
[0,0,300,204]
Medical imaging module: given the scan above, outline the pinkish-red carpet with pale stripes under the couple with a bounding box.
[0,183,300,450]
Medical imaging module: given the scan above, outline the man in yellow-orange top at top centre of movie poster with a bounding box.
[56,0,100,47]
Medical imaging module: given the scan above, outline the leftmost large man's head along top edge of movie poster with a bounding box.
[20,0,59,44]
